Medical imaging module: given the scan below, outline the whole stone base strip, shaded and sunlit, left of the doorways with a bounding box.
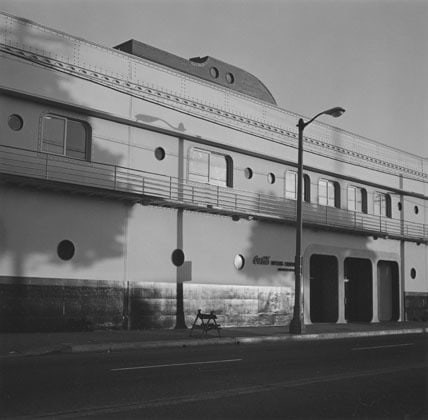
[0,278,294,332]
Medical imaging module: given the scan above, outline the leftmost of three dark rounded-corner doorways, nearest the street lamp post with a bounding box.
[309,255,338,322]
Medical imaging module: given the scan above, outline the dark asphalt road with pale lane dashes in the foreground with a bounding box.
[0,335,428,419]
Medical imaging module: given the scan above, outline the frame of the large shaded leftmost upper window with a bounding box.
[40,113,92,161]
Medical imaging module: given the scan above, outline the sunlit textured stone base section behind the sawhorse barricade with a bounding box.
[131,283,294,328]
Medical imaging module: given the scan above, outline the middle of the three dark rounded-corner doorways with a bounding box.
[344,258,373,322]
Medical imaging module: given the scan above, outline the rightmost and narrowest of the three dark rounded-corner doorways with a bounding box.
[377,261,400,321]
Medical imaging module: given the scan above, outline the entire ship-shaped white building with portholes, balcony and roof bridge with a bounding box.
[0,14,428,331]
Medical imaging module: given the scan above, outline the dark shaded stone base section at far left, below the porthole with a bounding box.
[0,282,123,332]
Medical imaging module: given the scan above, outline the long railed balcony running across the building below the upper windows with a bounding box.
[0,146,428,243]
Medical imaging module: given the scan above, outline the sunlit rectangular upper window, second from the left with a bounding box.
[189,149,233,187]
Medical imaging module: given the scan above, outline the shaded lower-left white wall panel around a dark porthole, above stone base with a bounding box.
[0,186,129,281]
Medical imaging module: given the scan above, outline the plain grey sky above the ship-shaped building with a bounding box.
[0,0,428,158]
